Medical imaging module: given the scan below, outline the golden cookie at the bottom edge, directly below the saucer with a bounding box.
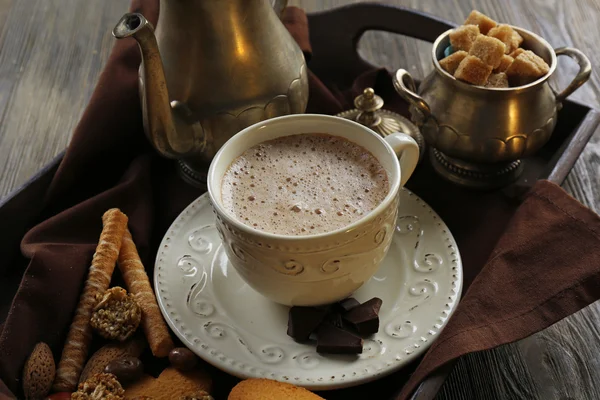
[227,379,324,400]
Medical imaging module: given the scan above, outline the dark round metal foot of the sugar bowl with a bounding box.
[429,148,523,190]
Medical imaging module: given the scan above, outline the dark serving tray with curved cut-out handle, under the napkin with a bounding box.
[0,4,600,400]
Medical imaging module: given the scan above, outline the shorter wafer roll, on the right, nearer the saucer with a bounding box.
[119,229,174,357]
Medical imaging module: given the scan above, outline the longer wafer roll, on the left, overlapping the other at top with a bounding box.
[52,208,127,392]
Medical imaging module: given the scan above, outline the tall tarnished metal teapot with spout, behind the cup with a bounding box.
[113,0,308,184]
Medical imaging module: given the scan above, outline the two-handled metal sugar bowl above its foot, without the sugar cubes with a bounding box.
[394,27,591,164]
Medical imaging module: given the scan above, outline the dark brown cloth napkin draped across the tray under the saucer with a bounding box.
[0,0,600,399]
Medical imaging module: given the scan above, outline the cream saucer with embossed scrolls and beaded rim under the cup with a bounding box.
[154,189,463,390]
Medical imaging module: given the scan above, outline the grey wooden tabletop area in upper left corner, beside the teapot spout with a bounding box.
[0,0,128,197]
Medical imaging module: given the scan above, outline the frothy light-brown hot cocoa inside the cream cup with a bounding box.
[221,134,389,236]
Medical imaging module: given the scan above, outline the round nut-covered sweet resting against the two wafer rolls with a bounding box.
[90,286,142,342]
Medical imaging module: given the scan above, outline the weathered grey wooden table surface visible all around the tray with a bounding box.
[0,0,600,400]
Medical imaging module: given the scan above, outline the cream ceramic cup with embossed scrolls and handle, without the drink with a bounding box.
[208,114,419,306]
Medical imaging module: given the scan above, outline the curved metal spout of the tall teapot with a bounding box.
[112,13,204,158]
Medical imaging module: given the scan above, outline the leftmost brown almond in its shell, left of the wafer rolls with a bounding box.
[23,342,56,399]
